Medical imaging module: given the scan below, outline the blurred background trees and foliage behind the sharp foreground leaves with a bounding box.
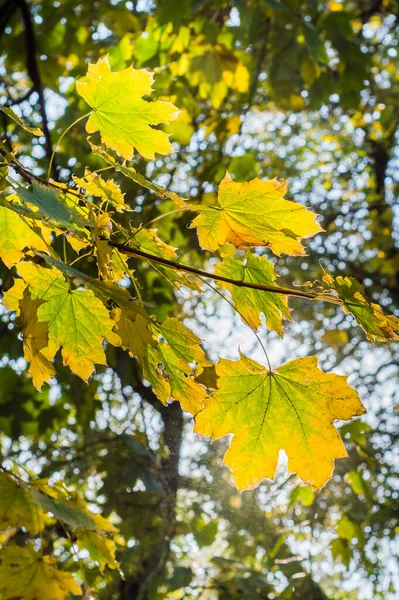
[0,0,399,600]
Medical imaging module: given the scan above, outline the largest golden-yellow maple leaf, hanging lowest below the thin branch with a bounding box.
[195,355,366,491]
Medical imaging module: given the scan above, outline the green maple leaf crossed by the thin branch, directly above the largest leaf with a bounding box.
[215,254,290,336]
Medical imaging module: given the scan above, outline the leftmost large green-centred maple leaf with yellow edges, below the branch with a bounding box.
[18,262,117,381]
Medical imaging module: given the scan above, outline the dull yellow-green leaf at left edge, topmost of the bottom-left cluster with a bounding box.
[0,473,44,536]
